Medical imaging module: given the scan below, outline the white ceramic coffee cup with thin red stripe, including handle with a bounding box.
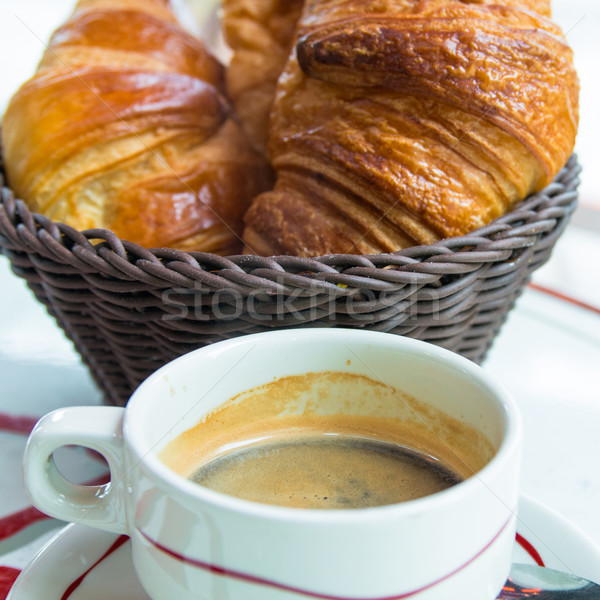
[25,329,522,600]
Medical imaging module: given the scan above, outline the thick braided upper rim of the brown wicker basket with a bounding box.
[0,154,581,291]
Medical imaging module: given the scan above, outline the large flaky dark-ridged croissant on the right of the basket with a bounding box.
[244,0,579,256]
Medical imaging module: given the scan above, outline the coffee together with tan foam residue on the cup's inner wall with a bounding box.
[159,371,494,509]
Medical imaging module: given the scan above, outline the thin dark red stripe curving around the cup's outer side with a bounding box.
[138,516,512,600]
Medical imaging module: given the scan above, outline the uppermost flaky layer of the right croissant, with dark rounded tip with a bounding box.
[297,2,578,186]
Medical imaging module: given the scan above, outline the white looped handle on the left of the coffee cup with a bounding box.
[24,406,128,533]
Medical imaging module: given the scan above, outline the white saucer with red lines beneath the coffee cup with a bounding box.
[7,497,600,600]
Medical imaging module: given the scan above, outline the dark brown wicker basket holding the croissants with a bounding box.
[0,157,579,405]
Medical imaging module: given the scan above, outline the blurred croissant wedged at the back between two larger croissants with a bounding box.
[222,0,304,154]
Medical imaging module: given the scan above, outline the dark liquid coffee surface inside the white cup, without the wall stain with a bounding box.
[190,432,462,509]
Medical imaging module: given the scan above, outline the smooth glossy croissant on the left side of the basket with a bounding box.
[2,0,271,254]
